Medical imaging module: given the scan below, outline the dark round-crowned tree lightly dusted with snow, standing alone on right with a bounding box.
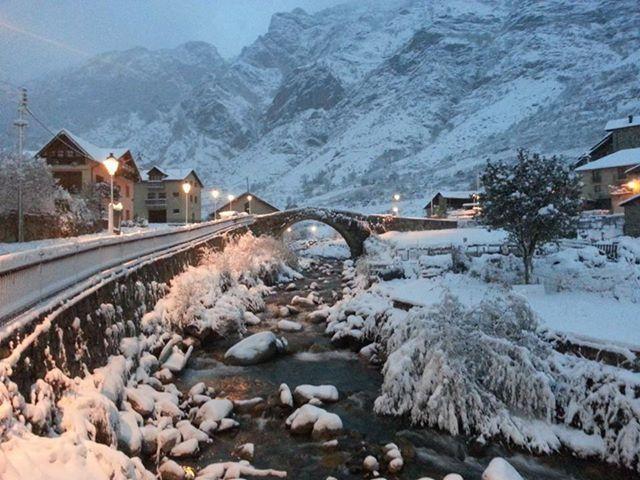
[480,150,581,283]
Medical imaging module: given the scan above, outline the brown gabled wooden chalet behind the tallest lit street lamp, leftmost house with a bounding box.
[36,129,140,220]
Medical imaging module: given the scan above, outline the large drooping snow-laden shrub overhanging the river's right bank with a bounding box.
[375,295,555,445]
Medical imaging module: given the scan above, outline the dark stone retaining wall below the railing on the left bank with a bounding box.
[0,237,232,394]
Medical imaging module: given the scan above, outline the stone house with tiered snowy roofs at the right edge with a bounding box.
[576,115,640,213]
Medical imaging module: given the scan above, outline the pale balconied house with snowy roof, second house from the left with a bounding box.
[135,166,203,223]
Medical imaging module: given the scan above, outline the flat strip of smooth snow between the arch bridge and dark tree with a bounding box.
[380,227,507,248]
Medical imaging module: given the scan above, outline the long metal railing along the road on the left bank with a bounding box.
[0,216,254,325]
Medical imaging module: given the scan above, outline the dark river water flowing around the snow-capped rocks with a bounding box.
[178,261,633,480]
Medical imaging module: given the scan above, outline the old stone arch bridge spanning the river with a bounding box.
[249,208,457,257]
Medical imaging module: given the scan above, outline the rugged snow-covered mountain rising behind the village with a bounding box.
[5,0,640,214]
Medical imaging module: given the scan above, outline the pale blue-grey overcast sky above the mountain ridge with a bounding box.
[0,0,348,82]
